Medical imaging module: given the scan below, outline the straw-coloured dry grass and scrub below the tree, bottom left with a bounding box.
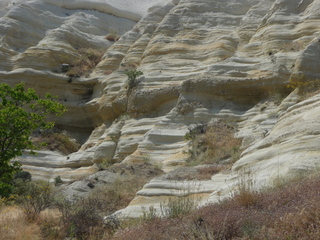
[0,163,160,240]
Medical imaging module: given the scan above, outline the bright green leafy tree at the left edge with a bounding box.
[0,83,66,197]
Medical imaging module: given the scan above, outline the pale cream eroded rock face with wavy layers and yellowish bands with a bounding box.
[0,0,320,217]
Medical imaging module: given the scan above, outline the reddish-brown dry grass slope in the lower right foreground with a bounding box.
[113,173,320,240]
